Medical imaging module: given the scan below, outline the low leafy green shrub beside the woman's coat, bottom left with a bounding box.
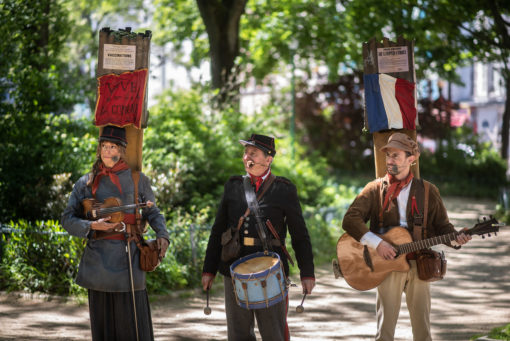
[0,220,84,295]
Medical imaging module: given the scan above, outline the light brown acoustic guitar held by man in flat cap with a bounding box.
[333,217,504,290]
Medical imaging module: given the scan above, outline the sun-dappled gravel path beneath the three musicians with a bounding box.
[0,198,510,341]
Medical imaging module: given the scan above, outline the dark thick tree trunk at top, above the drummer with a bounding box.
[197,0,247,89]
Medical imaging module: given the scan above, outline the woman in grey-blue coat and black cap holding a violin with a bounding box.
[62,126,169,341]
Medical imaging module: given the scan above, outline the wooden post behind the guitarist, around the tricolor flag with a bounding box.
[363,37,420,178]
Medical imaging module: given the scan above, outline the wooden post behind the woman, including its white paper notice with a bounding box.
[96,27,152,171]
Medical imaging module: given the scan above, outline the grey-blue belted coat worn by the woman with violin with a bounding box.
[61,169,169,292]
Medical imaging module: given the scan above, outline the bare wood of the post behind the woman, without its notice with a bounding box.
[96,27,152,171]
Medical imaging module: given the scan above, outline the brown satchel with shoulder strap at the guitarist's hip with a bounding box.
[413,181,446,282]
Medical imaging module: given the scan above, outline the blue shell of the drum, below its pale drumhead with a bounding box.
[230,252,288,309]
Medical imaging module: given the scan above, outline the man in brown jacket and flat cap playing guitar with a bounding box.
[342,133,471,341]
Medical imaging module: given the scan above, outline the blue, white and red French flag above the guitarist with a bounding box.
[363,73,417,133]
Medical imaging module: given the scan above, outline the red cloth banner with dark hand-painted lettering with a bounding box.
[95,69,147,129]
